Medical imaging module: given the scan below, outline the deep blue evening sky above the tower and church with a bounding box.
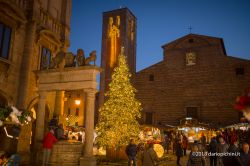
[69,0,250,71]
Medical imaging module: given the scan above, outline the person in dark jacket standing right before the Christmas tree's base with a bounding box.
[126,139,137,166]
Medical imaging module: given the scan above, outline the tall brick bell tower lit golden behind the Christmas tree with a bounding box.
[99,8,136,106]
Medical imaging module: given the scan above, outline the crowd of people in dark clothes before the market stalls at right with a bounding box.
[164,130,250,166]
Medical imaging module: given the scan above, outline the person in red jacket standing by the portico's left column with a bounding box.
[43,129,57,166]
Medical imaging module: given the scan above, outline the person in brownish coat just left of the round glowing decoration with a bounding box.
[142,144,158,166]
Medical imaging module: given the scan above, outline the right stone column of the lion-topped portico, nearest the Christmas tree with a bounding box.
[80,89,96,166]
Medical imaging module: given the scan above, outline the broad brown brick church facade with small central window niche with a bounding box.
[134,34,250,126]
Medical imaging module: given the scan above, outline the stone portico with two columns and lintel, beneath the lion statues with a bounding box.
[35,66,101,166]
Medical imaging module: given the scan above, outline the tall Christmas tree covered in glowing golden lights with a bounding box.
[97,48,142,147]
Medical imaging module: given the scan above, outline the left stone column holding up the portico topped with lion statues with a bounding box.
[35,91,47,148]
